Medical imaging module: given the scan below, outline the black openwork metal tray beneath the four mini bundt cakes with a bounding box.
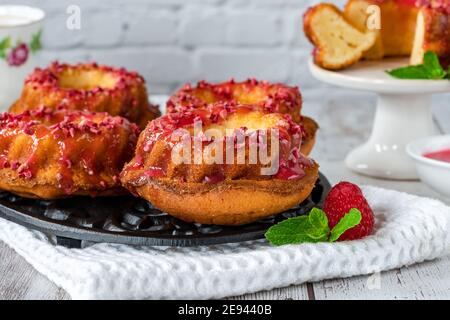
[0,174,331,248]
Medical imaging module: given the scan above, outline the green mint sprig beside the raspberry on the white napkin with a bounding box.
[265,208,362,246]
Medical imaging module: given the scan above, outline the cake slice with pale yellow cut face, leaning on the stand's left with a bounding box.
[303,3,377,70]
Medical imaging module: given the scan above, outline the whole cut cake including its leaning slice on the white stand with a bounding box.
[303,0,450,70]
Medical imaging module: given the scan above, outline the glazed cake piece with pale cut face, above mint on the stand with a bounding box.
[411,1,450,68]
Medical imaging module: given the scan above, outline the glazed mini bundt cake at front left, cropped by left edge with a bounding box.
[0,107,139,199]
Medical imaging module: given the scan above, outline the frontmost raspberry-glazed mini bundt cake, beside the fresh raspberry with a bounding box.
[121,103,318,225]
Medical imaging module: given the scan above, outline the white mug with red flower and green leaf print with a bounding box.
[0,5,45,112]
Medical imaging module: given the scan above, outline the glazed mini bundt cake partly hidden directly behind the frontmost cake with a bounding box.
[167,79,318,155]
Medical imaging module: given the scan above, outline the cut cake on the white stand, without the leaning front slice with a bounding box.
[344,0,450,66]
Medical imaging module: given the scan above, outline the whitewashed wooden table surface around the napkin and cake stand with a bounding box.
[0,91,450,300]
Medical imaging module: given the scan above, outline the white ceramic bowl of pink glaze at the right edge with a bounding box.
[406,135,450,197]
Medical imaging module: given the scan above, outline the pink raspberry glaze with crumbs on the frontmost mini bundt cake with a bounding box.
[130,102,312,183]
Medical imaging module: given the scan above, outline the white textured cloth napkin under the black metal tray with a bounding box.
[0,187,450,299]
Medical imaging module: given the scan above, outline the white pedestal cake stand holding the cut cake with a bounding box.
[309,59,450,180]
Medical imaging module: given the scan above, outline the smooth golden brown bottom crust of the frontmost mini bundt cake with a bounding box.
[125,164,318,225]
